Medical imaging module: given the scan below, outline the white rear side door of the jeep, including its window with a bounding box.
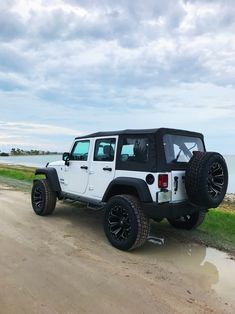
[87,136,118,199]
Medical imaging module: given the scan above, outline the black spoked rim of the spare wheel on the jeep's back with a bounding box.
[208,162,224,198]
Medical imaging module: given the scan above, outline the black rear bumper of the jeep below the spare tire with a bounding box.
[142,201,207,219]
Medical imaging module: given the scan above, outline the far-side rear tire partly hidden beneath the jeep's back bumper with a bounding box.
[167,211,207,230]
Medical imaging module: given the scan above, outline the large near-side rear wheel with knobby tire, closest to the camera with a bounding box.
[104,194,150,251]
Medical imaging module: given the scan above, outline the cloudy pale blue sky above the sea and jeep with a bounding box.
[0,0,235,154]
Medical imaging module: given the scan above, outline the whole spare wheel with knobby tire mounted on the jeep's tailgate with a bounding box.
[185,152,228,208]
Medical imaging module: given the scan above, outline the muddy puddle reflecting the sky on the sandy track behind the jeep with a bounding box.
[146,236,235,300]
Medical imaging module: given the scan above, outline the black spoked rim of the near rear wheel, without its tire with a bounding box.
[108,205,131,242]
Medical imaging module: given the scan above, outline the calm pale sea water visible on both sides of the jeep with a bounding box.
[0,155,235,193]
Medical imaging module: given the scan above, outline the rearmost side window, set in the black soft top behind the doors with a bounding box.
[120,137,149,163]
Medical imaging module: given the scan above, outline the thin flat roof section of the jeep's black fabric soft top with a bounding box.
[76,128,203,139]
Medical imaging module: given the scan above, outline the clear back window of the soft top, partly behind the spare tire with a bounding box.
[163,134,204,163]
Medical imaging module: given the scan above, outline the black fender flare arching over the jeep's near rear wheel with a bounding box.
[102,177,153,203]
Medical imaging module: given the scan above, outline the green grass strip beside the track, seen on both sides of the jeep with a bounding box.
[0,165,235,252]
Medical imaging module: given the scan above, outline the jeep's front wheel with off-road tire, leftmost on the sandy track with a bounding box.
[31,179,56,216]
